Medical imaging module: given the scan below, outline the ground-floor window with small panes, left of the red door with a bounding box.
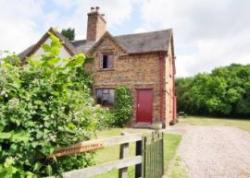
[96,88,115,106]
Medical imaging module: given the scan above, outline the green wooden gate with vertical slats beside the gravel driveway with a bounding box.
[142,132,164,178]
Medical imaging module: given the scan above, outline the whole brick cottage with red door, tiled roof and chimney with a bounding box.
[19,7,176,127]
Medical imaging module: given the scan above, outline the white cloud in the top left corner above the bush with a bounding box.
[0,0,42,52]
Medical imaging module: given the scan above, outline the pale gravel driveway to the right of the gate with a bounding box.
[170,125,250,178]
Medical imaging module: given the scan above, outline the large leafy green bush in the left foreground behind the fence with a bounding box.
[0,35,106,177]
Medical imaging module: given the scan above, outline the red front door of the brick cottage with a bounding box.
[136,89,153,123]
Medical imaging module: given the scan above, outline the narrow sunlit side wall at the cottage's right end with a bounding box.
[164,40,174,123]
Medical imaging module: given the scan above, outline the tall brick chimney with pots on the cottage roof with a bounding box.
[87,6,106,41]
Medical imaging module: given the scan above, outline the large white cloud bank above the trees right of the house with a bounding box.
[141,0,250,76]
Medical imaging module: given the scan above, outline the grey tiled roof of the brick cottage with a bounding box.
[19,29,172,58]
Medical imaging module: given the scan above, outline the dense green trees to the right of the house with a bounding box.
[176,64,250,117]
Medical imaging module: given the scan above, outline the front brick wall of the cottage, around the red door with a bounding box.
[85,38,160,125]
